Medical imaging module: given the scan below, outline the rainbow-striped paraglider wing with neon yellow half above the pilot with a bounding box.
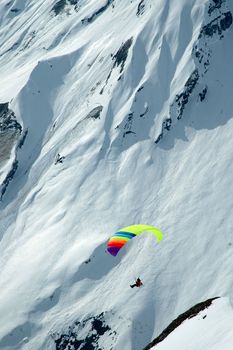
[107,224,163,256]
